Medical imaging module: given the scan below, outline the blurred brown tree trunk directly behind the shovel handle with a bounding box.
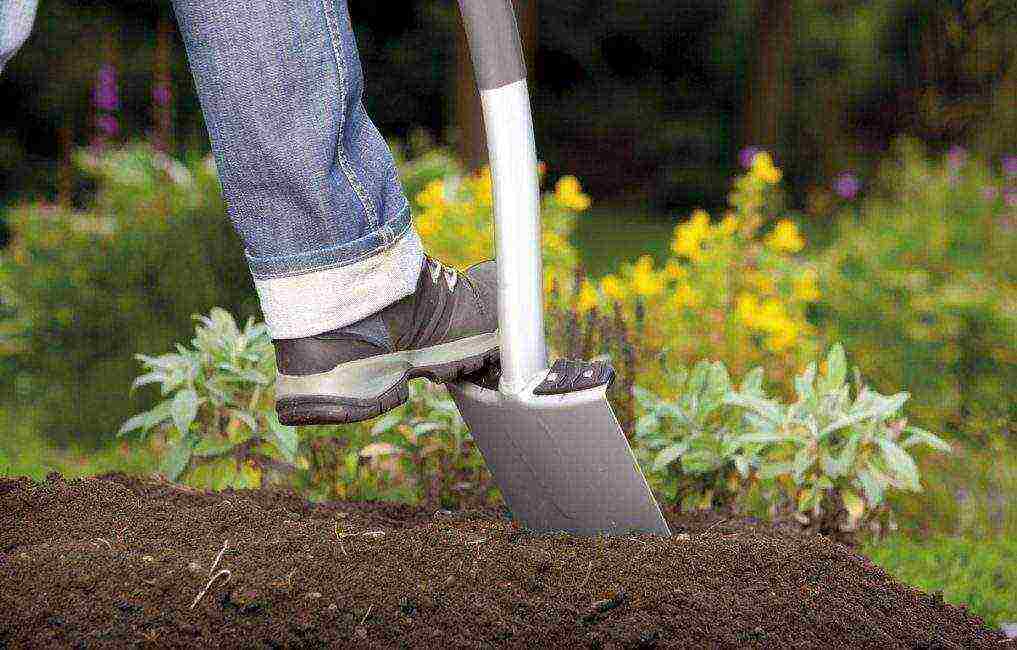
[456,0,538,171]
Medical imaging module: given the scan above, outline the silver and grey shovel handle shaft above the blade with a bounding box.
[459,0,547,395]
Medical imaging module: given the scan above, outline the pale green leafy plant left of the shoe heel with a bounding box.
[118,307,299,489]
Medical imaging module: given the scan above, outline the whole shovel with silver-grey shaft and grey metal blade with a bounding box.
[448,0,671,536]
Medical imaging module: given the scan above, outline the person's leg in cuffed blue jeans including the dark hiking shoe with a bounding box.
[174,0,498,424]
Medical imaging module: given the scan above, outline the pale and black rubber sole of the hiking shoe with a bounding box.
[276,330,498,426]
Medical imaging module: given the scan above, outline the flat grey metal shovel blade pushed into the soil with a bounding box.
[448,381,671,536]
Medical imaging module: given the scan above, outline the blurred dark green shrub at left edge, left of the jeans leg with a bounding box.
[0,144,257,445]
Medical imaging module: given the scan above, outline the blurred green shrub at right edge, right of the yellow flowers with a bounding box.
[819,140,1017,441]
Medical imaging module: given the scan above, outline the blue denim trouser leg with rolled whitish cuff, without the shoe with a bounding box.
[170,0,423,339]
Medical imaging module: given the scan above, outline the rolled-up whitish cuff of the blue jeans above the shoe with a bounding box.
[254,227,424,339]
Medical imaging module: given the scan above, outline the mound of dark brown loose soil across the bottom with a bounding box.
[0,474,1017,648]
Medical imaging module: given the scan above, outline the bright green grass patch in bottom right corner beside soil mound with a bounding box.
[862,535,1017,628]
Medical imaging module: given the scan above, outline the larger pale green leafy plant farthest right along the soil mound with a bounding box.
[726,345,951,531]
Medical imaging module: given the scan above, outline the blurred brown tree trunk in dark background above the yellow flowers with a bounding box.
[742,0,794,157]
